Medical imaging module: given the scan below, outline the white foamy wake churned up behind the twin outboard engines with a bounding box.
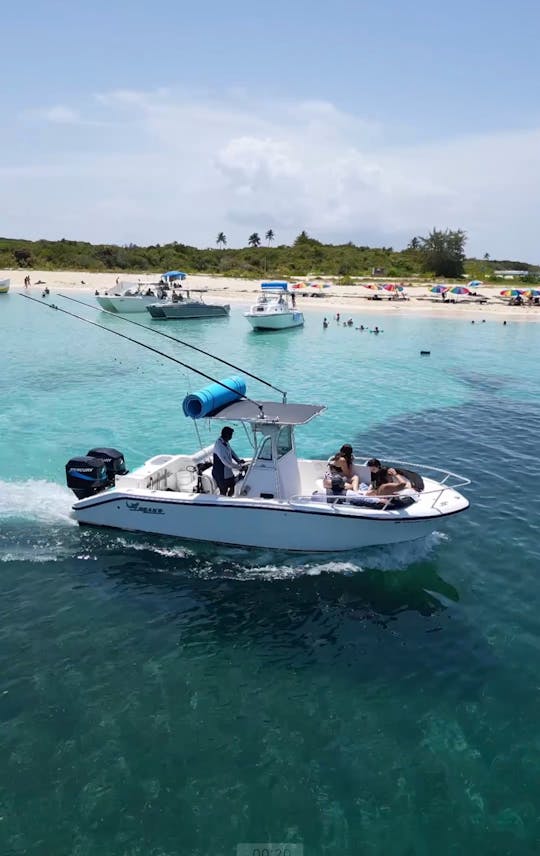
[0,479,77,526]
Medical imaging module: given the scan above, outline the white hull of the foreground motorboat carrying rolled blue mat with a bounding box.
[73,488,469,553]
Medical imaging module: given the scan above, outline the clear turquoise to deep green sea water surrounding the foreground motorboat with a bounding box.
[0,294,540,856]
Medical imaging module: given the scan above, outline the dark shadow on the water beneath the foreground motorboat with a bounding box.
[81,534,496,698]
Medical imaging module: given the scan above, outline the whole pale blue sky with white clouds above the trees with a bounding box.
[0,0,540,262]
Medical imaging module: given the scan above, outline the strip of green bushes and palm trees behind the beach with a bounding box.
[0,229,540,284]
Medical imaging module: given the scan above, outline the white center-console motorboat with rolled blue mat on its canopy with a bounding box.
[66,377,469,553]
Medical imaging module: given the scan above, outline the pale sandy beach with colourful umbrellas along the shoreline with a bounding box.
[4,270,540,321]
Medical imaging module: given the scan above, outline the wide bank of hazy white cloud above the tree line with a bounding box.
[6,89,540,261]
